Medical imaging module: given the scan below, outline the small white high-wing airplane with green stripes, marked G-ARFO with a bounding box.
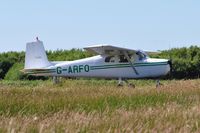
[22,38,171,86]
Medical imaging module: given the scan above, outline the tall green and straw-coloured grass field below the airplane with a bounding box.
[0,80,200,132]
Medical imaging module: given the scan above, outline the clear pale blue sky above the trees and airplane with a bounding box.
[0,0,200,52]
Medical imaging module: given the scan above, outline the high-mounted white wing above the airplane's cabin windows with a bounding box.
[84,45,137,55]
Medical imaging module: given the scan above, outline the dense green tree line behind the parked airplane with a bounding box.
[0,46,200,80]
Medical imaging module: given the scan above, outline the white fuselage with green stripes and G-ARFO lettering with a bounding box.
[32,55,170,78]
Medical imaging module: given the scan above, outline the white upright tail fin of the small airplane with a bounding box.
[24,39,51,69]
